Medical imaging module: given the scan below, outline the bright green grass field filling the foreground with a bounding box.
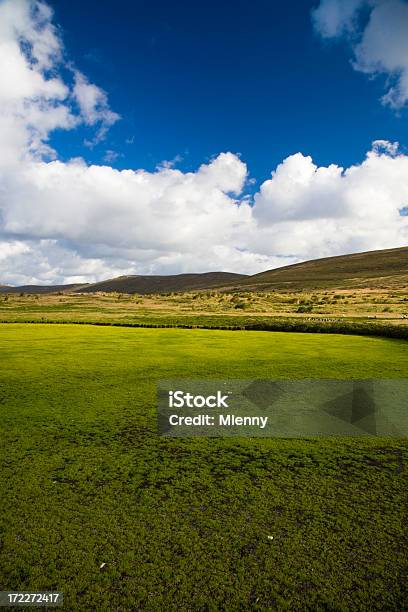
[0,324,408,612]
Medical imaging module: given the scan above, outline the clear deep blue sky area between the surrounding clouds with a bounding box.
[51,0,408,181]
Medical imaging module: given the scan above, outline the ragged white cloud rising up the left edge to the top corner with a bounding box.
[0,0,118,163]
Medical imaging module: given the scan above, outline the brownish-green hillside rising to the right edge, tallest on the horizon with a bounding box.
[234,247,408,290]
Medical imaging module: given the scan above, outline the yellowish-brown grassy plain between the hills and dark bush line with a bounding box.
[0,289,408,325]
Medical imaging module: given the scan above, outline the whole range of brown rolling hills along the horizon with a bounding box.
[0,247,408,294]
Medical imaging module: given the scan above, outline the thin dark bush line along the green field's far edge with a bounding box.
[1,319,408,340]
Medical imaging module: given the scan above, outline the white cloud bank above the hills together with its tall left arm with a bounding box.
[0,0,408,284]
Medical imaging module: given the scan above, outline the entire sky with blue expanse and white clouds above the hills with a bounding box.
[0,0,408,284]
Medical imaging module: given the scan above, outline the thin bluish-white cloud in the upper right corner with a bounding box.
[312,0,408,109]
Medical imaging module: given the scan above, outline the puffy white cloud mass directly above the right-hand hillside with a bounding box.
[253,140,408,259]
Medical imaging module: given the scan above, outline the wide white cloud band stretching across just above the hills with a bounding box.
[0,141,408,282]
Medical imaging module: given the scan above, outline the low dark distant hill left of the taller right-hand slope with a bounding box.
[76,272,247,294]
